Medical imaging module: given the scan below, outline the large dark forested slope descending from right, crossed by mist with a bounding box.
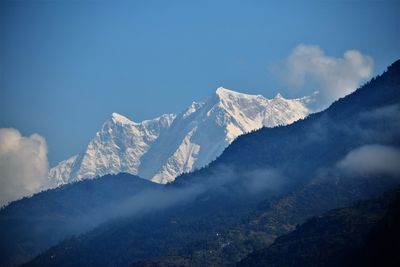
[3,62,400,266]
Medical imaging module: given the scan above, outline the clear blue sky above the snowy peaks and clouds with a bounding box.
[0,0,400,165]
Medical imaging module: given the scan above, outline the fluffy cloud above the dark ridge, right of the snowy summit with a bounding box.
[278,44,374,107]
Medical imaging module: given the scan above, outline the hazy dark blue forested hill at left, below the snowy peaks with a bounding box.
[0,173,159,266]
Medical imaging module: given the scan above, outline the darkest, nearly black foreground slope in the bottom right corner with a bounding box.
[237,187,400,267]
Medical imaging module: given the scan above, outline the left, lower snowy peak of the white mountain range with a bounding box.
[49,113,175,185]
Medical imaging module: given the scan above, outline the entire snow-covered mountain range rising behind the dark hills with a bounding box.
[49,87,313,186]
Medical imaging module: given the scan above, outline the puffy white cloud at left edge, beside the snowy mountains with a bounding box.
[0,128,49,206]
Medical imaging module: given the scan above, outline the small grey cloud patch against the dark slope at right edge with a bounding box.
[337,144,400,177]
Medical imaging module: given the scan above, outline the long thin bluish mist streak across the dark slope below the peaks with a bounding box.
[74,165,287,227]
